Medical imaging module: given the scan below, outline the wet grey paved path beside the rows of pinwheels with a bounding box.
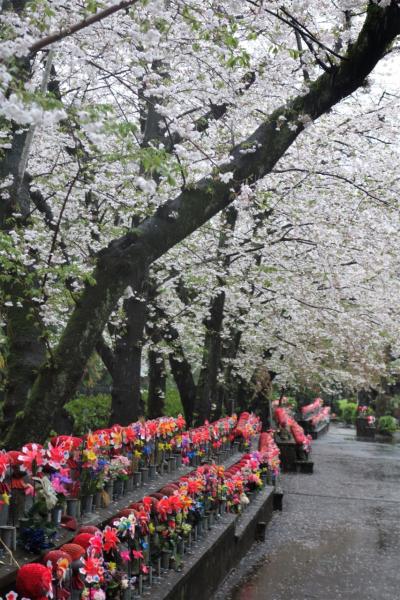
[214,426,400,600]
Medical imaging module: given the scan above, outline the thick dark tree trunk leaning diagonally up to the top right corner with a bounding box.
[6,2,400,446]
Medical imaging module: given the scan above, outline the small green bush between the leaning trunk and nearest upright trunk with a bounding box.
[65,394,111,435]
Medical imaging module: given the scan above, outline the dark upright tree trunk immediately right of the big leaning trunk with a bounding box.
[110,297,147,425]
